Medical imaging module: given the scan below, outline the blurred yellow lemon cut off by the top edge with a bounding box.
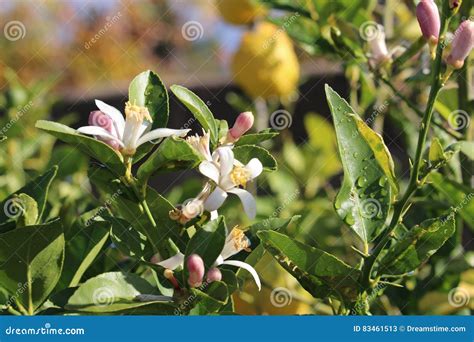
[216,0,266,25]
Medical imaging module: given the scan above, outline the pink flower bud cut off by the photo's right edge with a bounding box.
[446,20,474,69]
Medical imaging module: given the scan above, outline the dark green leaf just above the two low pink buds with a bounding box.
[184,216,227,279]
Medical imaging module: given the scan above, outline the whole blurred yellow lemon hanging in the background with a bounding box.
[232,22,300,99]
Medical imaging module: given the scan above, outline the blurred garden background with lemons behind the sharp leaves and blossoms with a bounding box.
[0,0,474,314]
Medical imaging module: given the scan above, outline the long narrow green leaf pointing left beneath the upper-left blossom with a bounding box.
[36,120,125,176]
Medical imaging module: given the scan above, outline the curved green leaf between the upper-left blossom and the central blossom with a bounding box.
[137,137,203,184]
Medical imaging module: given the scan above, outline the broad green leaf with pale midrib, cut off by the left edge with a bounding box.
[0,220,64,313]
